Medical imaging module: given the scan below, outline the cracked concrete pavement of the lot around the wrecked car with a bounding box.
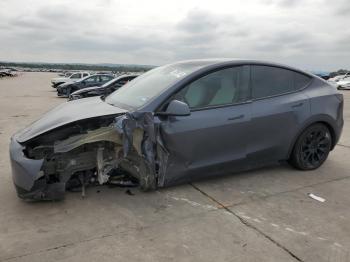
[0,73,350,262]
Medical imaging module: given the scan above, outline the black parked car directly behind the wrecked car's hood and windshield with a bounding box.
[68,74,139,100]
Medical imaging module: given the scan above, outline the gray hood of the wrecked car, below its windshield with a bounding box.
[15,97,127,143]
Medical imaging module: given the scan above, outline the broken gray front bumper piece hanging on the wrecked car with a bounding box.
[10,137,65,200]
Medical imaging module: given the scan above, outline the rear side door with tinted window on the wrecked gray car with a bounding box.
[247,65,310,166]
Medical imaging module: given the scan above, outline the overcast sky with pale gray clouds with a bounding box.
[0,0,350,70]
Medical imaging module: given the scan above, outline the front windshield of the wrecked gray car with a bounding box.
[106,64,203,108]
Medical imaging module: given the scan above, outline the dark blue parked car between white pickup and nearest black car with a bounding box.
[57,74,114,97]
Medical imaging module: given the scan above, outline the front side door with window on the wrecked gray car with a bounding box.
[160,66,251,184]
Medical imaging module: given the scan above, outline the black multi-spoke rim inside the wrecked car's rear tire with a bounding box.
[301,129,331,168]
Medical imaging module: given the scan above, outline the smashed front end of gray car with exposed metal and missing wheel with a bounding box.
[10,113,165,200]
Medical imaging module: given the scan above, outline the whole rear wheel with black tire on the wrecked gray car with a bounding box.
[288,124,332,170]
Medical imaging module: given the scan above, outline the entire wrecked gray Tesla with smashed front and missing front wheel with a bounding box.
[10,60,343,200]
